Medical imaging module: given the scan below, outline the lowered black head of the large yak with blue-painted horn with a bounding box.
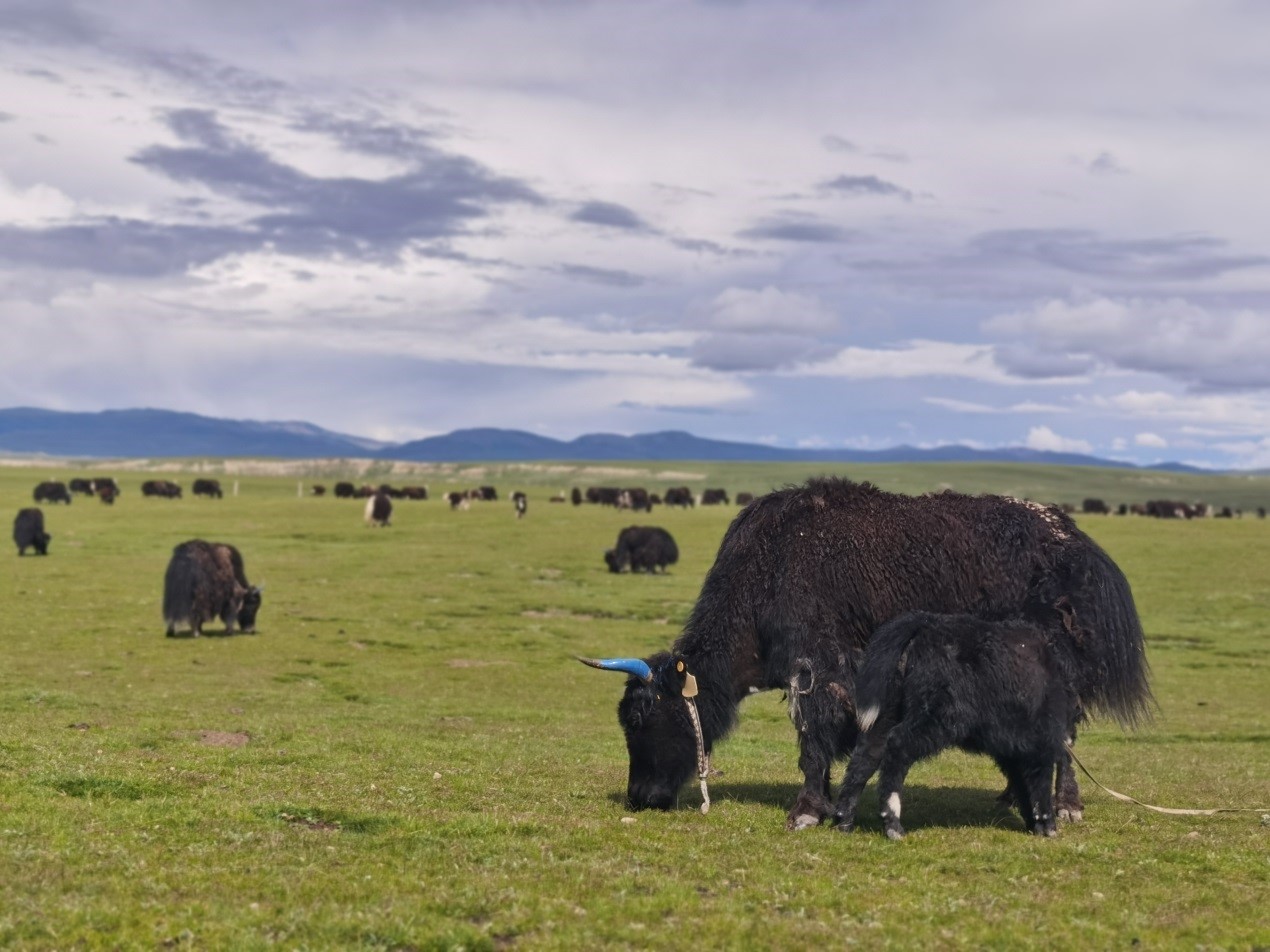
[578,651,697,810]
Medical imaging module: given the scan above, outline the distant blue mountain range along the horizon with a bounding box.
[0,407,1201,472]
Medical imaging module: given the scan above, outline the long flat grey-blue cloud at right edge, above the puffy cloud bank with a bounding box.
[970,228,1270,281]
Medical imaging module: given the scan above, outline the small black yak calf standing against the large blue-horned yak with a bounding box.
[834,612,1081,839]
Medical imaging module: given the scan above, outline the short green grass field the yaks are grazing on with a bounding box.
[0,463,1270,949]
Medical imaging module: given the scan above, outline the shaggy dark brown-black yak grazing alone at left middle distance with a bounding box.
[163,539,262,637]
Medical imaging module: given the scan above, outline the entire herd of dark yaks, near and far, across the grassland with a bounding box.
[14,477,1265,839]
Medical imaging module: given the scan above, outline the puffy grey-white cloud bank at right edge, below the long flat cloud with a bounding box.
[983,297,1270,390]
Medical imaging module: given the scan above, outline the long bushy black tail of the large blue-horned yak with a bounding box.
[1069,543,1154,727]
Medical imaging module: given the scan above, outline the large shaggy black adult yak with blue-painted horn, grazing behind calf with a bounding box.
[581,479,1151,829]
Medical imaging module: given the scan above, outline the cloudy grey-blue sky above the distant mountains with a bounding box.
[0,0,1270,468]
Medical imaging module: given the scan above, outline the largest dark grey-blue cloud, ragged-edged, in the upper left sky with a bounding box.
[132,109,542,256]
